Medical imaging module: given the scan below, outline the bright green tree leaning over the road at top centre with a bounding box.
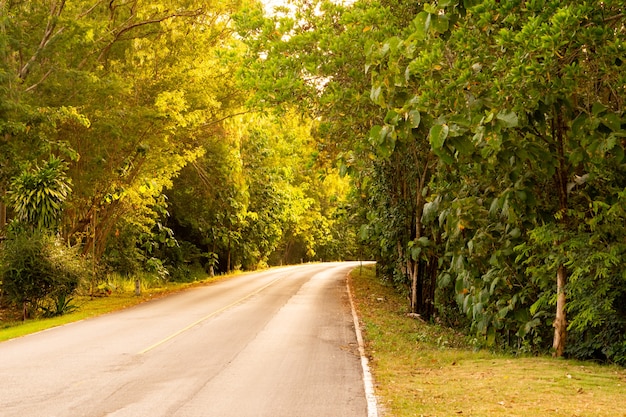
[237,1,429,312]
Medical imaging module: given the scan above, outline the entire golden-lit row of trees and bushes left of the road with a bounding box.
[0,0,357,317]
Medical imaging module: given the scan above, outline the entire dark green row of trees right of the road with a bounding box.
[240,0,626,364]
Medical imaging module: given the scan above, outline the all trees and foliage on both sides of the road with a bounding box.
[0,0,626,364]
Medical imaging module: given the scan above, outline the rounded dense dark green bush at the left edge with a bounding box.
[0,232,89,319]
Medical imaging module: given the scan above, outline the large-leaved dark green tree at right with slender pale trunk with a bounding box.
[372,1,624,355]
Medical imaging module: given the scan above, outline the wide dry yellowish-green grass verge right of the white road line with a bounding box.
[351,268,626,417]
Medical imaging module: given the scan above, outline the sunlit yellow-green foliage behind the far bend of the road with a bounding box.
[168,113,351,272]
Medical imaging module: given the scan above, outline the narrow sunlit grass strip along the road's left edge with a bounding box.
[0,275,230,342]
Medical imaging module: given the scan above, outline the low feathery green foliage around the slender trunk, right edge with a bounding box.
[516,192,626,364]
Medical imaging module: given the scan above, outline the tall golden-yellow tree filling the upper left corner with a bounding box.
[0,1,252,266]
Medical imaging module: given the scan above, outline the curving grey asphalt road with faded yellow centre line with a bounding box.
[0,263,368,417]
